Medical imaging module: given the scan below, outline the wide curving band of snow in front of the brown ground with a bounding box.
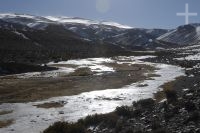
[0,57,184,133]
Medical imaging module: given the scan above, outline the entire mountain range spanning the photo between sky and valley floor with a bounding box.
[0,13,200,61]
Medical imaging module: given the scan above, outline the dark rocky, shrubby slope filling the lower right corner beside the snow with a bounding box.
[44,51,200,133]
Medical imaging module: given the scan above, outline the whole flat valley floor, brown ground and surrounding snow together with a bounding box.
[0,57,183,133]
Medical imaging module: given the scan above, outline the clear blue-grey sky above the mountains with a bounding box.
[0,0,200,29]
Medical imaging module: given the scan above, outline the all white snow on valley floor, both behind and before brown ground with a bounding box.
[0,56,184,133]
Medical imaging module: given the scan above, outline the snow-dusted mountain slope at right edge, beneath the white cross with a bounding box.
[157,24,200,61]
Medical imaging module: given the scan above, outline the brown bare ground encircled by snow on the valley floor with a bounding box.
[0,64,155,104]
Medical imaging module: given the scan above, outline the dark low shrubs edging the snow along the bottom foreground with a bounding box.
[44,99,155,133]
